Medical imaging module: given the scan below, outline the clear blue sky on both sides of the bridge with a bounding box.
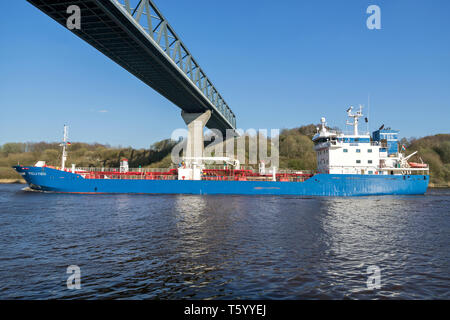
[0,0,450,147]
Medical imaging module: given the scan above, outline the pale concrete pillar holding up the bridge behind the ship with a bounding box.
[181,110,211,165]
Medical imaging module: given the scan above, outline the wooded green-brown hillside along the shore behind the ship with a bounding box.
[0,124,450,186]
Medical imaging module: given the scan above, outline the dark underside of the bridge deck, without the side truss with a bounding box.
[27,0,233,133]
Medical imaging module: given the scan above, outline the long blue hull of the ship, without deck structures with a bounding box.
[14,166,429,196]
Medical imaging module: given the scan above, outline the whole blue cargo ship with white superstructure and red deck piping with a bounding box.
[13,107,429,197]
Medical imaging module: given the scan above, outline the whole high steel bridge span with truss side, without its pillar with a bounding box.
[27,0,236,133]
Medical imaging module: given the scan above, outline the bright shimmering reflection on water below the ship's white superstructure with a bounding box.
[314,196,444,298]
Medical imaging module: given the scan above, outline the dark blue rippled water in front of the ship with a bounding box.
[0,185,450,299]
